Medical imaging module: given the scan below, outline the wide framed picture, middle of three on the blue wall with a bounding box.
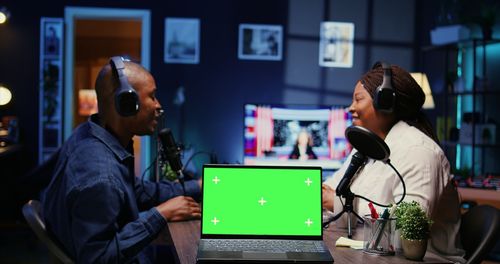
[238,24,283,61]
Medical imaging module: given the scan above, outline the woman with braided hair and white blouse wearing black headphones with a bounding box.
[323,62,463,256]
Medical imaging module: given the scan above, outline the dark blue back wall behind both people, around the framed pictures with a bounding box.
[0,0,446,176]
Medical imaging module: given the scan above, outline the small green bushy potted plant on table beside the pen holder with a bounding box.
[395,201,432,260]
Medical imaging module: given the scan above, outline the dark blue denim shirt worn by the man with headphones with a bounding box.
[42,115,200,263]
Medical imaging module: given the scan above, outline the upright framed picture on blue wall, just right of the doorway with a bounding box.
[164,18,200,64]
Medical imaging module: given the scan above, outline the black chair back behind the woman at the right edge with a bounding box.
[460,205,500,264]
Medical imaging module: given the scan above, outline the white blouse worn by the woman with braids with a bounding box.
[325,121,464,256]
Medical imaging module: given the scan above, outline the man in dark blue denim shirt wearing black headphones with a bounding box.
[42,57,201,263]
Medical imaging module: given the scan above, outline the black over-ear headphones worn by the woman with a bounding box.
[372,61,396,113]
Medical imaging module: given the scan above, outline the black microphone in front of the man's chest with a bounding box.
[158,128,186,194]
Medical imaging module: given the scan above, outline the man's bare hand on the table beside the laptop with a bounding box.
[156,196,201,221]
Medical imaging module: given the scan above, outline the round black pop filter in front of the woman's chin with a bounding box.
[345,126,391,161]
